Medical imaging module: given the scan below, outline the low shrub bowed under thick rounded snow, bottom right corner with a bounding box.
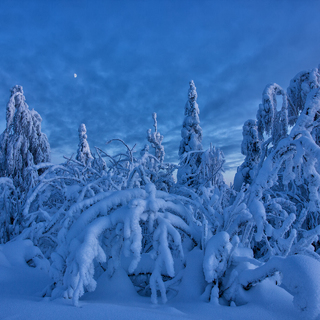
[202,232,320,319]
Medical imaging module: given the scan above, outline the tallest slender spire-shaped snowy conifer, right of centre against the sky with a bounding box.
[179,80,202,156]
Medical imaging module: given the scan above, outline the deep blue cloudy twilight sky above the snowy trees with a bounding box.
[0,0,320,181]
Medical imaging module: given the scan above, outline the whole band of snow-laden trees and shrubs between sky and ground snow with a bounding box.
[0,63,320,319]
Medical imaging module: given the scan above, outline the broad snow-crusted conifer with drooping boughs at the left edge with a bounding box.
[0,85,50,178]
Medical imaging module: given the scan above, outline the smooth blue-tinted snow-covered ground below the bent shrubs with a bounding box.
[0,241,307,320]
